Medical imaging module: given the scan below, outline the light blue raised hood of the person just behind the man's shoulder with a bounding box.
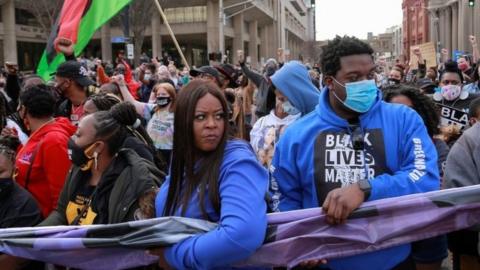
[271,61,320,115]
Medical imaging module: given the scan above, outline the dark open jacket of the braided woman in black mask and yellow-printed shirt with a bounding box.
[39,149,165,226]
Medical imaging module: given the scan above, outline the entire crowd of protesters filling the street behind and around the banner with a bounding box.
[0,36,480,270]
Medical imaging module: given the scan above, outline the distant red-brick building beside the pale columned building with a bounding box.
[402,0,430,57]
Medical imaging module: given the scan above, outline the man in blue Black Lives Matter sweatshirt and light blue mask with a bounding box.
[271,36,440,270]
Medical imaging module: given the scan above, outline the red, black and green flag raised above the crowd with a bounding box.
[37,0,132,80]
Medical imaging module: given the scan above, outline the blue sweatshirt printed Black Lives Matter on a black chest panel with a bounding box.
[271,90,440,270]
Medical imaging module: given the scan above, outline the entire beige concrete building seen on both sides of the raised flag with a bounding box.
[0,0,315,70]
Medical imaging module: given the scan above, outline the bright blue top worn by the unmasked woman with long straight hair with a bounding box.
[155,140,268,269]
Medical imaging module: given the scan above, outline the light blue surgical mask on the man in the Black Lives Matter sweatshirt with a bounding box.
[332,77,378,113]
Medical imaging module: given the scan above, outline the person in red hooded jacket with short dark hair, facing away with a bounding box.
[15,85,76,217]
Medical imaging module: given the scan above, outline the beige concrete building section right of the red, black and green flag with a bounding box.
[95,0,315,67]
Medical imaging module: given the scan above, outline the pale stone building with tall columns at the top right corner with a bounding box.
[428,0,480,56]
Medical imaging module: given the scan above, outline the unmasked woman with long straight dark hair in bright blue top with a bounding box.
[155,80,268,269]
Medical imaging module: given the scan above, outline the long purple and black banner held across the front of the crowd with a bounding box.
[0,186,480,269]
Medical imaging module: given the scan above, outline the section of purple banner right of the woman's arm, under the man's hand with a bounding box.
[245,186,480,267]
